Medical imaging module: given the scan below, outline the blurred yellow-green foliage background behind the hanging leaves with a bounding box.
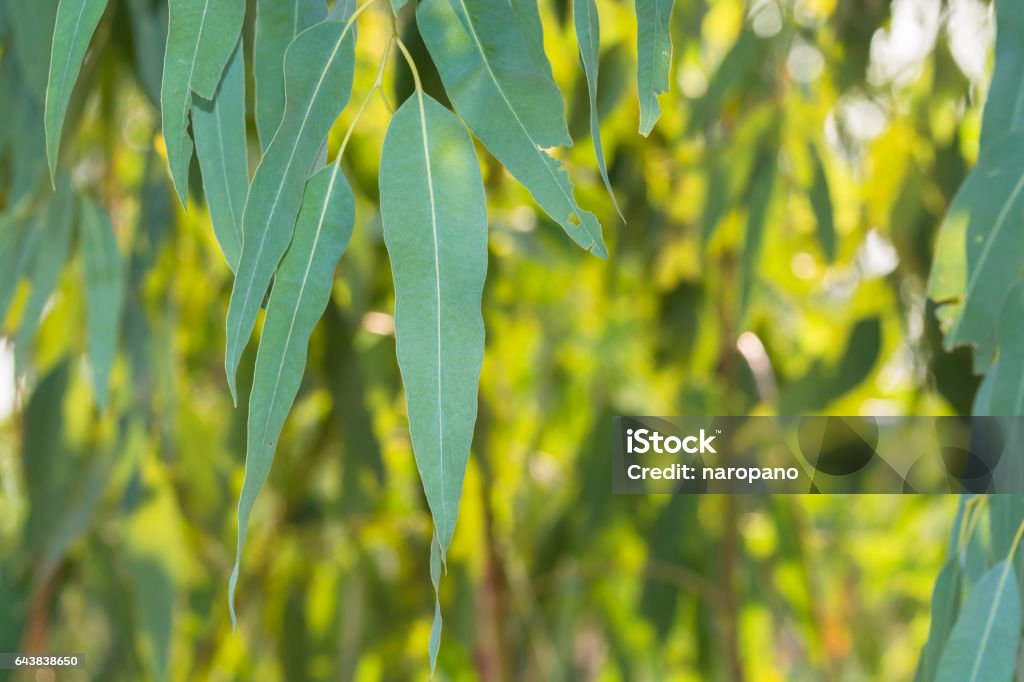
[0,0,991,682]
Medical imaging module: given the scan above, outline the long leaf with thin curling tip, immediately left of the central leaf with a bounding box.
[228,164,355,623]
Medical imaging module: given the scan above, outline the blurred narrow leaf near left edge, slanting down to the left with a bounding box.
[14,173,75,374]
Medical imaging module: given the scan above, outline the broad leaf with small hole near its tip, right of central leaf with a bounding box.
[416,0,608,258]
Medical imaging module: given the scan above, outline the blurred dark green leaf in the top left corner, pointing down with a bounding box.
[7,0,60,104]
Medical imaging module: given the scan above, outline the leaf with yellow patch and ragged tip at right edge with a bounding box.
[928,132,1024,373]
